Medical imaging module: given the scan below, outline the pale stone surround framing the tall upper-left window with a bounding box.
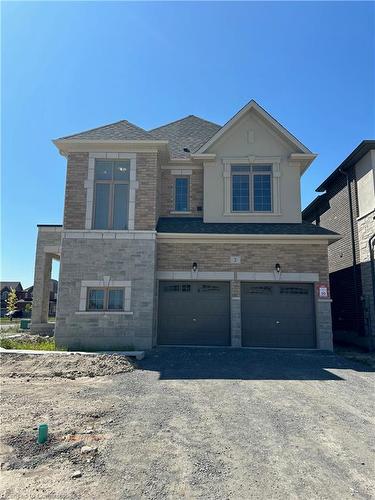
[85,152,138,232]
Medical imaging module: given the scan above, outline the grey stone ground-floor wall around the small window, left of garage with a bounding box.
[55,235,155,350]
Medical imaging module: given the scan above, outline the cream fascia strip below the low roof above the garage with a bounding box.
[156,233,341,244]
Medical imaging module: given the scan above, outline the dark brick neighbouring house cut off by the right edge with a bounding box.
[302,140,375,350]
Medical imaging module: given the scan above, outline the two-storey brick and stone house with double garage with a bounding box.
[32,101,340,350]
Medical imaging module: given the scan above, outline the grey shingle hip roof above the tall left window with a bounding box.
[61,120,155,141]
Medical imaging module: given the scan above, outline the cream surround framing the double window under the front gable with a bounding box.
[222,156,281,218]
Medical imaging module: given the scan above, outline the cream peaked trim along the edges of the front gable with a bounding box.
[195,99,312,155]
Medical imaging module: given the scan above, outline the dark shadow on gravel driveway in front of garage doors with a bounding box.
[138,347,374,380]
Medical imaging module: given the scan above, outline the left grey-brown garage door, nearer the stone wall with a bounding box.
[158,281,230,346]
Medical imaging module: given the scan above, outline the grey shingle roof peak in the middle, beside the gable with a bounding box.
[149,115,221,158]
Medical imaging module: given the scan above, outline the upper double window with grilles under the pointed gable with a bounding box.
[231,165,272,212]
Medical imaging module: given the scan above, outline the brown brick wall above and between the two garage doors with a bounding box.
[157,241,332,349]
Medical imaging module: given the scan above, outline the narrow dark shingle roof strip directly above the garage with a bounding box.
[156,217,337,235]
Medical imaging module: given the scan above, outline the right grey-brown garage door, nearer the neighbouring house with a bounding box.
[241,283,316,348]
